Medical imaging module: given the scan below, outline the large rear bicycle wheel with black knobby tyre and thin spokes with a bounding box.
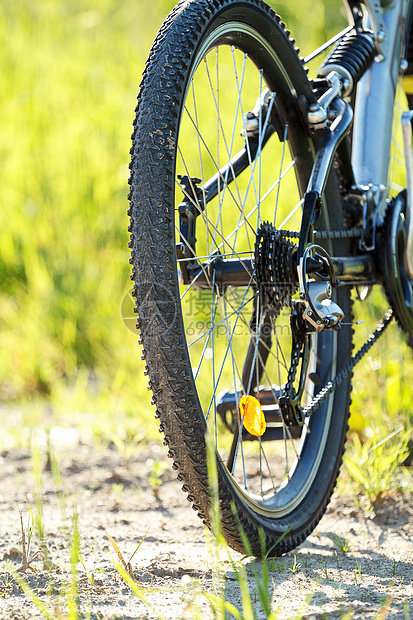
[129,0,351,555]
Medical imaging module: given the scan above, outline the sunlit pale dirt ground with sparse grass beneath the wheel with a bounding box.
[0,436,413,620]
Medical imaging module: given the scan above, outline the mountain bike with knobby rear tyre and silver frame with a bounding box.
[128,0,413,556]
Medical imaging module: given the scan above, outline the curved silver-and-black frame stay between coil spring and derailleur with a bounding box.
[297,97,353,260]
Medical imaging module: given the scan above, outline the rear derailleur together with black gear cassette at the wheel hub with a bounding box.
[254,223,344,432]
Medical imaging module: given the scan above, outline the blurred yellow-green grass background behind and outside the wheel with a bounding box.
[0,0,413,456]
